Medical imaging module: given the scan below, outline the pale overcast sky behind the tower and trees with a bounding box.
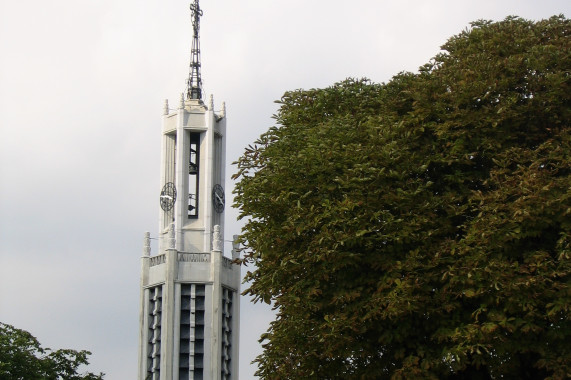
[0,0,571,380]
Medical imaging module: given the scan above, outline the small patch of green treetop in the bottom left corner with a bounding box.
[0,322,103,380]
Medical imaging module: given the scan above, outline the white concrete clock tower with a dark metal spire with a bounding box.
[138,0,240,380]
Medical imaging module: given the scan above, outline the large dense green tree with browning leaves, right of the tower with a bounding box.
[235,16,571,379]
